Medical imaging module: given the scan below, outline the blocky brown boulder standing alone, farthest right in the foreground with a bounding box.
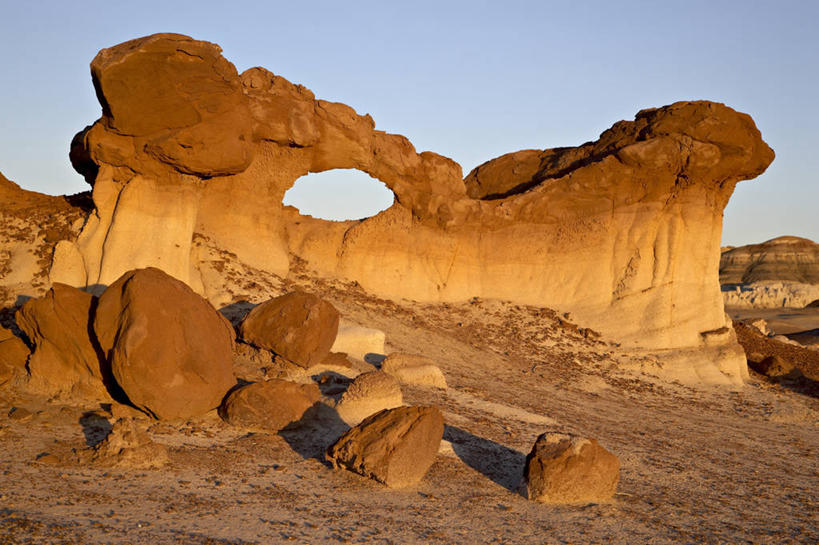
[524,432,620,503]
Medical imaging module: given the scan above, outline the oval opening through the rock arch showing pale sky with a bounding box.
[282,169,395,221]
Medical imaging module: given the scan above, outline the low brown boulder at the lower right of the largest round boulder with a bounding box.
[219,379,321,433]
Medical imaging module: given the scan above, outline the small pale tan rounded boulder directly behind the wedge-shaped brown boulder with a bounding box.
[336,371,404,426]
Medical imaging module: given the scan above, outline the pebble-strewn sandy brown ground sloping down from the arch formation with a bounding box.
[0,283,819,544]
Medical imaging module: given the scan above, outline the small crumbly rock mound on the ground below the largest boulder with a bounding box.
[77,418,169,469]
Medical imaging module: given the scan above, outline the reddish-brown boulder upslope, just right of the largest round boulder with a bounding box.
[240,291,339,368]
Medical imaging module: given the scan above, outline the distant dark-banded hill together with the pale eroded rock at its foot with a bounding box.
[719,236,819,308]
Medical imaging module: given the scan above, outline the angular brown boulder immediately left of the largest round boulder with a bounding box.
[17,284,110,400]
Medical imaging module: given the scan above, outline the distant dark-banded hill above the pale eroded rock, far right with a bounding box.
[719,236,819,284]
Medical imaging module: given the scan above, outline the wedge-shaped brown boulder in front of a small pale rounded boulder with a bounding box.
[327,407,444,488]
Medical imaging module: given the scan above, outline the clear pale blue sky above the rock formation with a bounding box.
[0,0,819,244]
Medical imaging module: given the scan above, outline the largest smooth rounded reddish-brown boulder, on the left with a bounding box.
[94,268,236,419]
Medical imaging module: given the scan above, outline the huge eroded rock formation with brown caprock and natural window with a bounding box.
[4,34,773,382]
